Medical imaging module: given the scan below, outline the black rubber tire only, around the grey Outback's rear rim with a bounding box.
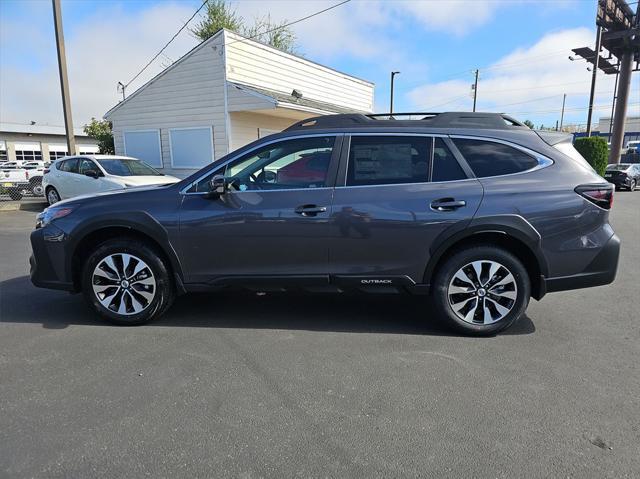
[431,245,531,336]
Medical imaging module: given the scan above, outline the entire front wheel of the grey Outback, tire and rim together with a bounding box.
[82,238,175,325]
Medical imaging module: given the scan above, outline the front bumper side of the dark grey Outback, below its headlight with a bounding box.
[29,225,75,292]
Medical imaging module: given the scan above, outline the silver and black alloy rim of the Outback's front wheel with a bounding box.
[91,253,156,316]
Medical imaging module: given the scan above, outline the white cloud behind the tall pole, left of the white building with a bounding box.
[0,2,197,127]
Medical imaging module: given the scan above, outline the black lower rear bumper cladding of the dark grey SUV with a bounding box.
[543,234,620,293]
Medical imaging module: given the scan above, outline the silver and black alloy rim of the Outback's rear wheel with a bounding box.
[447,260,518,324]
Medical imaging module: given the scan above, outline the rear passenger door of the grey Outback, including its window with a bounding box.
[329,134,483,286]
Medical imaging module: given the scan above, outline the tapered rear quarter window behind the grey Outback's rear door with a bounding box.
[453,138,538,178]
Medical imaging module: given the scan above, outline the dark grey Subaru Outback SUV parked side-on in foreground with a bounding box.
[31,113,620,335]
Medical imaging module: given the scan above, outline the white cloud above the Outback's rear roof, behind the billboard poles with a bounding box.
[407,28,638,126]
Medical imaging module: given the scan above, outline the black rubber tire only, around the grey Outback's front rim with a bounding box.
[82,238,175,326]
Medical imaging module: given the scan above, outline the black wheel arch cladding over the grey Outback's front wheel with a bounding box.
[67,213,184,293]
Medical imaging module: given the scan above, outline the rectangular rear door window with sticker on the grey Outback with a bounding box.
[347,136,431,186]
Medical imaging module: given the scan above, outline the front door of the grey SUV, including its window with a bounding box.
[178,135,342,284]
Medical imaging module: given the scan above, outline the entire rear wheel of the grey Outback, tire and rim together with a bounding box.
[432,245,531,336]
